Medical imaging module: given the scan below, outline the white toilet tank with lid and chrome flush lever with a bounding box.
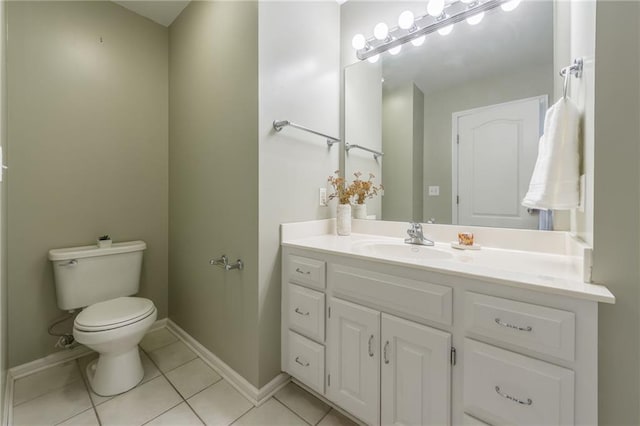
[49,241,147,311]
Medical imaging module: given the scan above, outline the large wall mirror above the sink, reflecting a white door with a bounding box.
[344,1,555,229]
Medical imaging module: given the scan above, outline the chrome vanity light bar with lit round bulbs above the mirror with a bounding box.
[351,0,521,63]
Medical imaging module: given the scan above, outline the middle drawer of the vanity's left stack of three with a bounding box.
[288,284,324,342]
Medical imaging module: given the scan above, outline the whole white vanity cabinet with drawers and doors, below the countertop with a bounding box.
[282,245,598,425]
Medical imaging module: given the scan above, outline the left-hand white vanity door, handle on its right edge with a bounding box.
[327,299,380,425]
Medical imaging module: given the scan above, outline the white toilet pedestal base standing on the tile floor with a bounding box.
[87,345,144,396]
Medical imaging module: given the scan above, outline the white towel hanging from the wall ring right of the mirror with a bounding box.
[522,98,580,210]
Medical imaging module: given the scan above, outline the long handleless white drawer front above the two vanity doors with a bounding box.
[329,264,453,325]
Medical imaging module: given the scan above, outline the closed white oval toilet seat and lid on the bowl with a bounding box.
[74,297,156,332]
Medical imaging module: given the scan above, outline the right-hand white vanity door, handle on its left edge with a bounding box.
[381,314,451,425]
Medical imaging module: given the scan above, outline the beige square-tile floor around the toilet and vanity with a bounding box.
[13,328,355,426]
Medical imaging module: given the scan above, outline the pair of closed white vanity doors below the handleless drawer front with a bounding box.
[327,298,451,425]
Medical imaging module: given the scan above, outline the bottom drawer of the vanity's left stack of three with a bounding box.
[287,331,324,395]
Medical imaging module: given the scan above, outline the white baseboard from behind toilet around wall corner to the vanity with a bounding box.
[167,320,291,406]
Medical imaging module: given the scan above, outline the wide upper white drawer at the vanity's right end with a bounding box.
[464,292,576,361]
